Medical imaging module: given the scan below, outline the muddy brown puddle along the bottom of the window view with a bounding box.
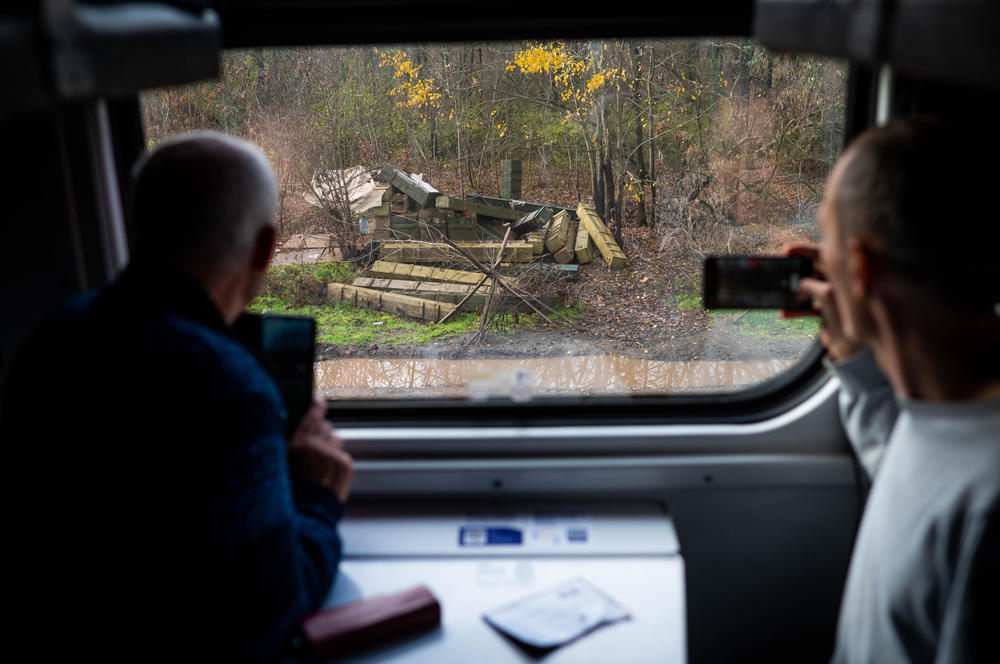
[315,355,797,400]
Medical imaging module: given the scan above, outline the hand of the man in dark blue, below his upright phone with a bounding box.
[288,396,354,503]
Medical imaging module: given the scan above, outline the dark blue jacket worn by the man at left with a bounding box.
[2,267,342,661]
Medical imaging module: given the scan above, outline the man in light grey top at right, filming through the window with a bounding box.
[795,118,1000,663]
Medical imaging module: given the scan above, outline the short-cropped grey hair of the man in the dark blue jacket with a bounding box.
[130,132,278,274]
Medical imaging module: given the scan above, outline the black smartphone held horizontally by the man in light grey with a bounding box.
[702,256,813,310]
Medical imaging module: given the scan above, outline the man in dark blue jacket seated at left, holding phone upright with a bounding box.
[3,133,352,661]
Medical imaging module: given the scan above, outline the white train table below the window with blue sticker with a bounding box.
[325,503,686,664]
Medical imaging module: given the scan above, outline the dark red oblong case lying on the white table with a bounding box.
[302,586,441,659]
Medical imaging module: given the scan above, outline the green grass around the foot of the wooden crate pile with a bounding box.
[250,262,583,345]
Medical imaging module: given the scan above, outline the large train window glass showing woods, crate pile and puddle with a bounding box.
[141,39,847,400]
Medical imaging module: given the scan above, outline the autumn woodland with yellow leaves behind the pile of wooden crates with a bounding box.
[142,39,847,312]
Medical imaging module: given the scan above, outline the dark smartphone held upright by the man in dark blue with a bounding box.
[233,313,316,435]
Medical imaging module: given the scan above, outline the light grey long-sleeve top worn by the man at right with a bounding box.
[832,352,1000,663]
